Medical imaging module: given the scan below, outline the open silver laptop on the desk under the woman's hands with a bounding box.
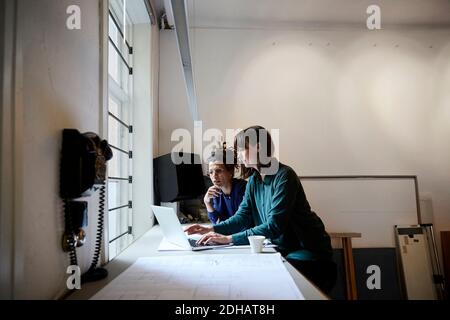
[152,206,232,251]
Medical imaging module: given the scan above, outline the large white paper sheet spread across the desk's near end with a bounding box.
[92,253,304,300]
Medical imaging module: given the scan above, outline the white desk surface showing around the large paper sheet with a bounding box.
[67,226,328,300]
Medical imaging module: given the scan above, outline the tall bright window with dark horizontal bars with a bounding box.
[107,0,150,260]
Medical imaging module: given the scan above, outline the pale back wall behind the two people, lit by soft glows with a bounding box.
[159,26,450,246]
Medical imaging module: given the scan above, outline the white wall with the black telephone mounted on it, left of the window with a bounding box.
[8,0,101,299]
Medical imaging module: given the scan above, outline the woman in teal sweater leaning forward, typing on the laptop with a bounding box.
[186,126,336,293]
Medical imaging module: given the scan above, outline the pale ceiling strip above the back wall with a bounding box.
[182,0,450,28]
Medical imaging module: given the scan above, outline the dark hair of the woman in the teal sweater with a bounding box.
[234,125,274,179]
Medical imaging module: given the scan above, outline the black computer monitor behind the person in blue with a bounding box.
[153,153,206,203]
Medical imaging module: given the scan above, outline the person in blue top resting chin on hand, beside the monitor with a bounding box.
[203,148,247,224]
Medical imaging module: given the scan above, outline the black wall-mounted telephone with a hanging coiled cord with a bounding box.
[60,129,112,282]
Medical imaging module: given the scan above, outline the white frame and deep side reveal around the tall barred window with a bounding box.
[100,0,155,263]
